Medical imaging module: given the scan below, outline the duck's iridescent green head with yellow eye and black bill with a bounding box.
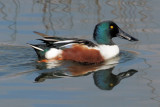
[93,21,138,45]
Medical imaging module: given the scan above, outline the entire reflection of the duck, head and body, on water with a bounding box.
[35,56,137,90]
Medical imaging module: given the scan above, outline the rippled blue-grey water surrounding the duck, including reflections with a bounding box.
[0,0,160,107]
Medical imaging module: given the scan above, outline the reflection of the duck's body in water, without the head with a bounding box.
[36,56,120,82]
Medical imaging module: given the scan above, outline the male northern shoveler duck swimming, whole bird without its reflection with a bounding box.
[29,21,138,63]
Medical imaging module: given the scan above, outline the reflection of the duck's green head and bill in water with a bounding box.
[93,67,137,90]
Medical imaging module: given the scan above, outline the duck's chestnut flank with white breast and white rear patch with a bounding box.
[45,44,119,63]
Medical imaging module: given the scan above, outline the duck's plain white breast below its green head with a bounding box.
[95,45,119,59]
